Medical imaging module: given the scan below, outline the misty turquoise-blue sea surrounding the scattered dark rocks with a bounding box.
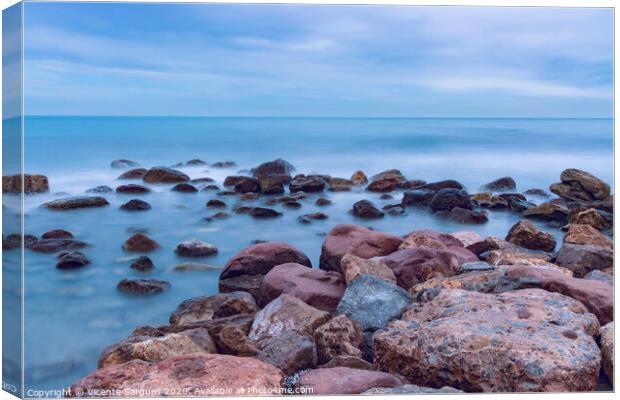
[4,117,613,389]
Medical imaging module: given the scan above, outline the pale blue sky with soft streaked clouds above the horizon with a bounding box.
[24,3,613,117]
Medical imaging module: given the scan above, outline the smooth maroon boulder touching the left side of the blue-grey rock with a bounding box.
[259,263,345,312]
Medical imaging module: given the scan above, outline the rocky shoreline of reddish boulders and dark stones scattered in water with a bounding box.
[3,159,614,397]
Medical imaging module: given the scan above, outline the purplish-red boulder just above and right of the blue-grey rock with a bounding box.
[382,246,460,289]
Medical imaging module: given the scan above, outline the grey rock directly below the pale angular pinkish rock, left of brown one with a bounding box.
[256,331,317,375]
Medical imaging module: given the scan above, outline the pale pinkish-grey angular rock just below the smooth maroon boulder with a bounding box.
[248,293,329,348]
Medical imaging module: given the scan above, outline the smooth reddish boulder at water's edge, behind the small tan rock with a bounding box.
[319,224,403,272]
